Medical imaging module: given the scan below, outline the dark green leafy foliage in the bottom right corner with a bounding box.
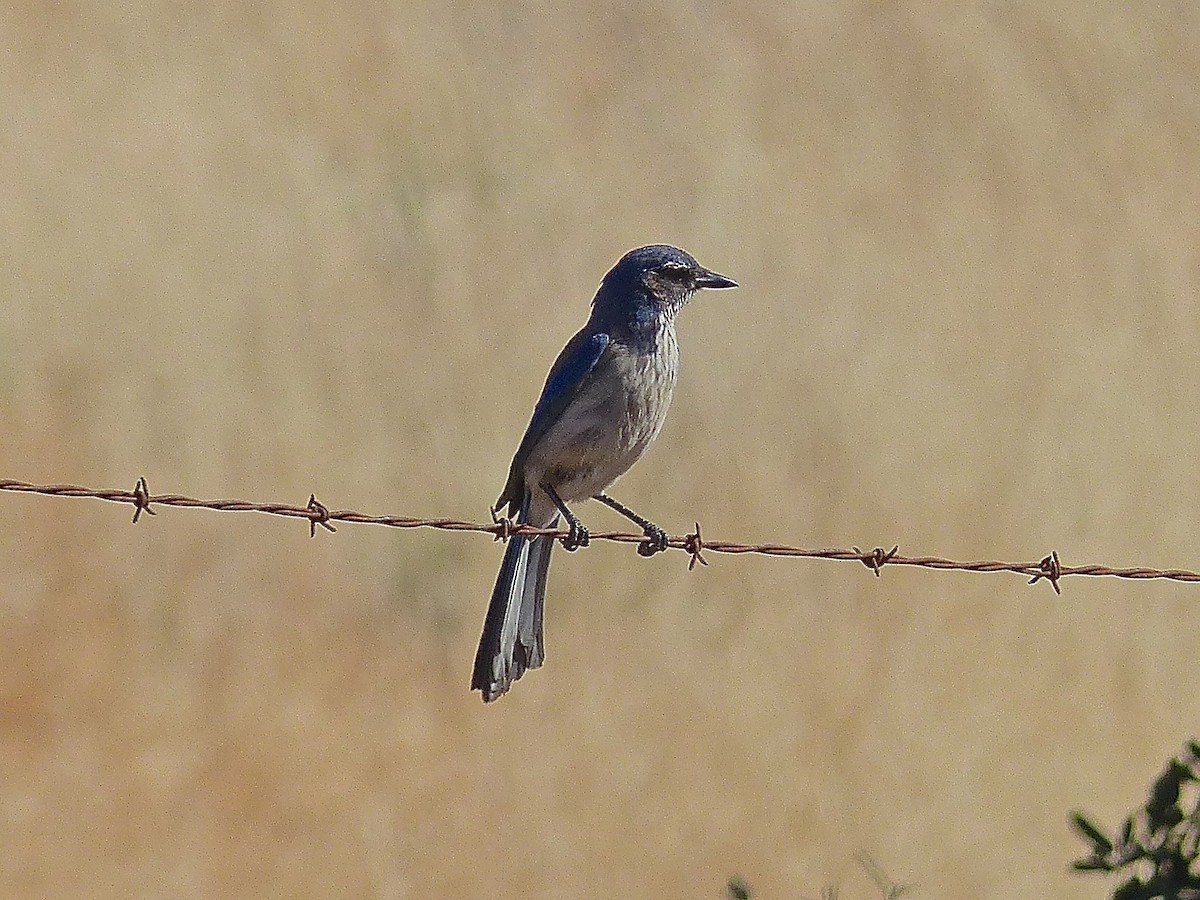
[1070,740,1200,900]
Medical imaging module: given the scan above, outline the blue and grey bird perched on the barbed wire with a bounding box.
[470,244,737,703]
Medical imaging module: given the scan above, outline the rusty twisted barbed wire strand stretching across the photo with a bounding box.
[0,478,1200,594]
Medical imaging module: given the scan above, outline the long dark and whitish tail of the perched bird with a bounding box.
[470,491,558,703]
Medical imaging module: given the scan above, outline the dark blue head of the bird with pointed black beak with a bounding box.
[593,244,738,326]
